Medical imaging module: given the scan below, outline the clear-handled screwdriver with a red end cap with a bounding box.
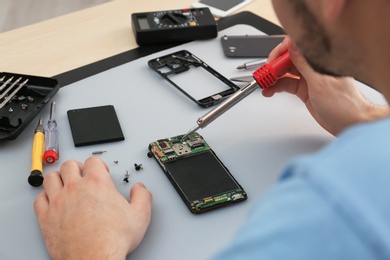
[43,101,60,164]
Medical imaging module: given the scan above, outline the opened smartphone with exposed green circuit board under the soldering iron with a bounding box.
[148,132,247,214]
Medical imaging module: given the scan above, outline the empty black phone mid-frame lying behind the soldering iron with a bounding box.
[148,50,240,107]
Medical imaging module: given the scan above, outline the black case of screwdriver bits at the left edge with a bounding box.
[0,72,59,140]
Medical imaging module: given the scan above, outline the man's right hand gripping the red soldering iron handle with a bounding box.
[262,37,390,135]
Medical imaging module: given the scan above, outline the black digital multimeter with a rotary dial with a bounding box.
[131,8,218,45]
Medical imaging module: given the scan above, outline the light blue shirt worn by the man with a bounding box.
[215,119,390,260]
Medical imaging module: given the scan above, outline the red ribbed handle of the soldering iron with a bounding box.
[253,51,293,89]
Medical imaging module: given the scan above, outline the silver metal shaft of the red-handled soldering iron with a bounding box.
[183,80,259,139]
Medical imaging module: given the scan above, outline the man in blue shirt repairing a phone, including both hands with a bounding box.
[34,0,390,259]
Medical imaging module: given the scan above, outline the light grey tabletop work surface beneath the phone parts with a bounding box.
[0,25,384,259]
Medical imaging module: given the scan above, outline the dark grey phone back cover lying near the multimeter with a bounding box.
[221,35,285,58]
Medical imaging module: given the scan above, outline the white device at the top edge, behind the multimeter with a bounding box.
[192,0,252,17]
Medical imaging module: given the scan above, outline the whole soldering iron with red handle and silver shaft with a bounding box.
[183,51,292,140]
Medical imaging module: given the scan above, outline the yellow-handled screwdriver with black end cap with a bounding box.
[28,118,45,187]
